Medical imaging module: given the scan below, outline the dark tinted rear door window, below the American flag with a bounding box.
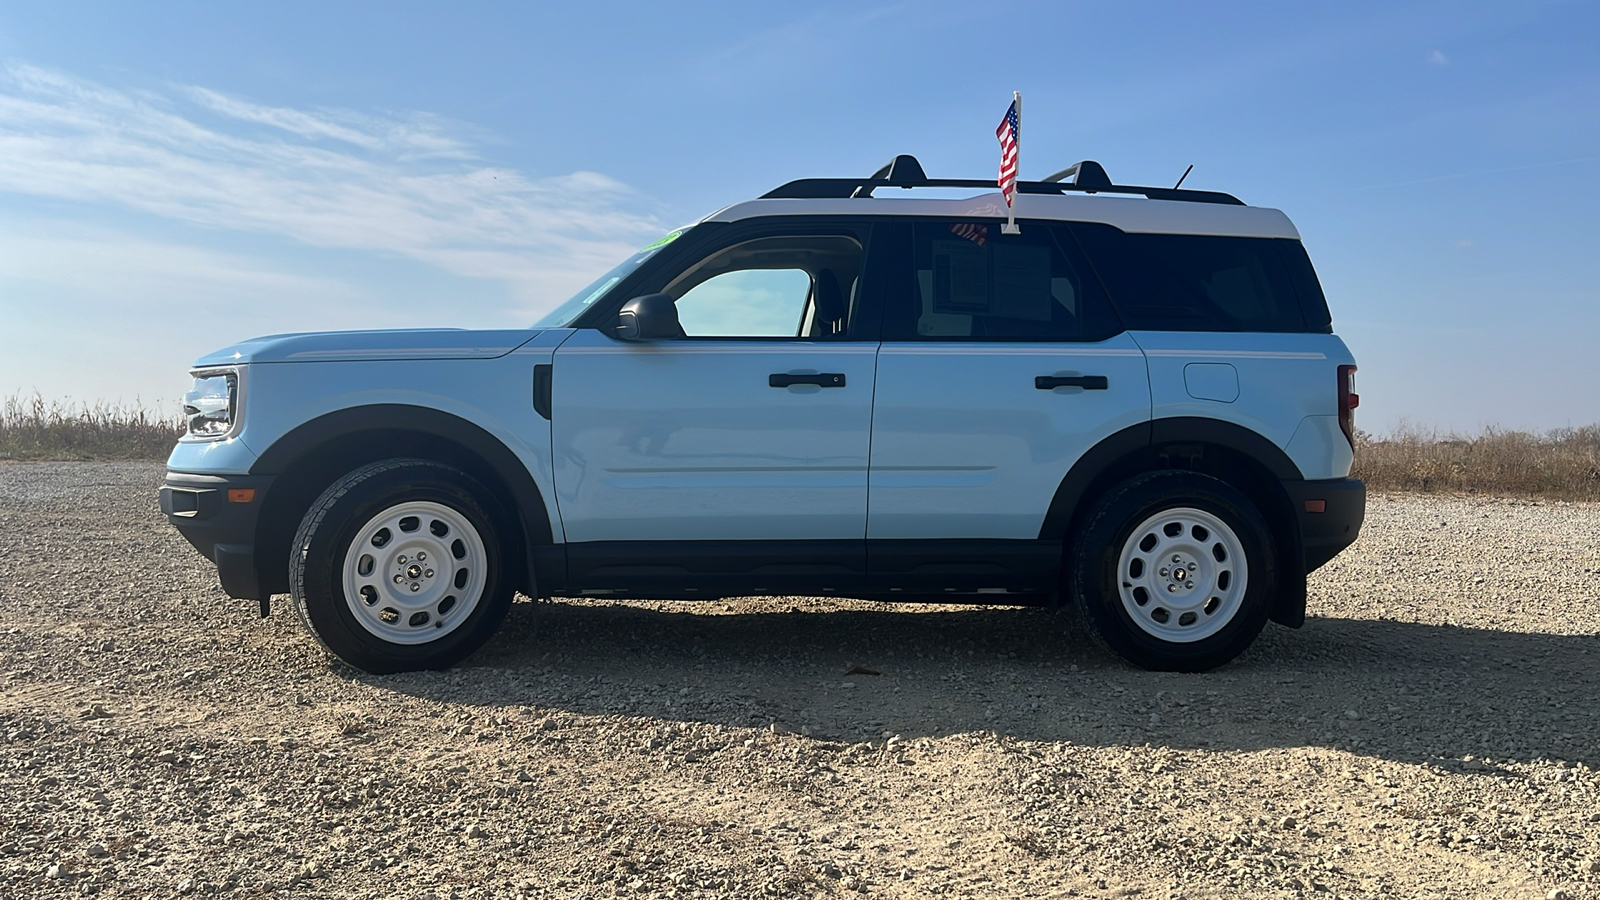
[885,221,1120,341]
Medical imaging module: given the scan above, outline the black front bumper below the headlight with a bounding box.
[160,471,274,601]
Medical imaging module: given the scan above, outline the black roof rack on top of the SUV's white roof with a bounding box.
[762,154,1245,207]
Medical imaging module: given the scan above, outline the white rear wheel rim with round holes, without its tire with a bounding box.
[1117,506,1250,644]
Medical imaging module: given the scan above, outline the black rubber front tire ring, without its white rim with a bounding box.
[290,461,510,674]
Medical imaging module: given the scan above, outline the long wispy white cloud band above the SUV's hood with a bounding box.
[0,64,661,314]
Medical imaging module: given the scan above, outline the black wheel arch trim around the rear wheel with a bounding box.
[1040,416,1306,628]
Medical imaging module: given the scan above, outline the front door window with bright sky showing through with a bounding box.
[666,235,861,340]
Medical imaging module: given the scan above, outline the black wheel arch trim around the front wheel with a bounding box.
[250,404,555,593]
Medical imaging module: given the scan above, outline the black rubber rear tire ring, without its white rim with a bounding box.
[1072,472,1277,671]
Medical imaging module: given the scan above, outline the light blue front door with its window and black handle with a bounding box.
[550,226,878,547]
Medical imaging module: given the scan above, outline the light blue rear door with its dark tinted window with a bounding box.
[867,219,1150,538]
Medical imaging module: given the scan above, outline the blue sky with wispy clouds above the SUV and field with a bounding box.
[0,0,1600,431]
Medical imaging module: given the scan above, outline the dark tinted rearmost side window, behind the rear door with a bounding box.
[1070,223,1326,331]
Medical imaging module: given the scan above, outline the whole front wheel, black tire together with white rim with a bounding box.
[290,460,512,674]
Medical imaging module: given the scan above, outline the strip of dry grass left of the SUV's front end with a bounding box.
[0,394,182,460]
